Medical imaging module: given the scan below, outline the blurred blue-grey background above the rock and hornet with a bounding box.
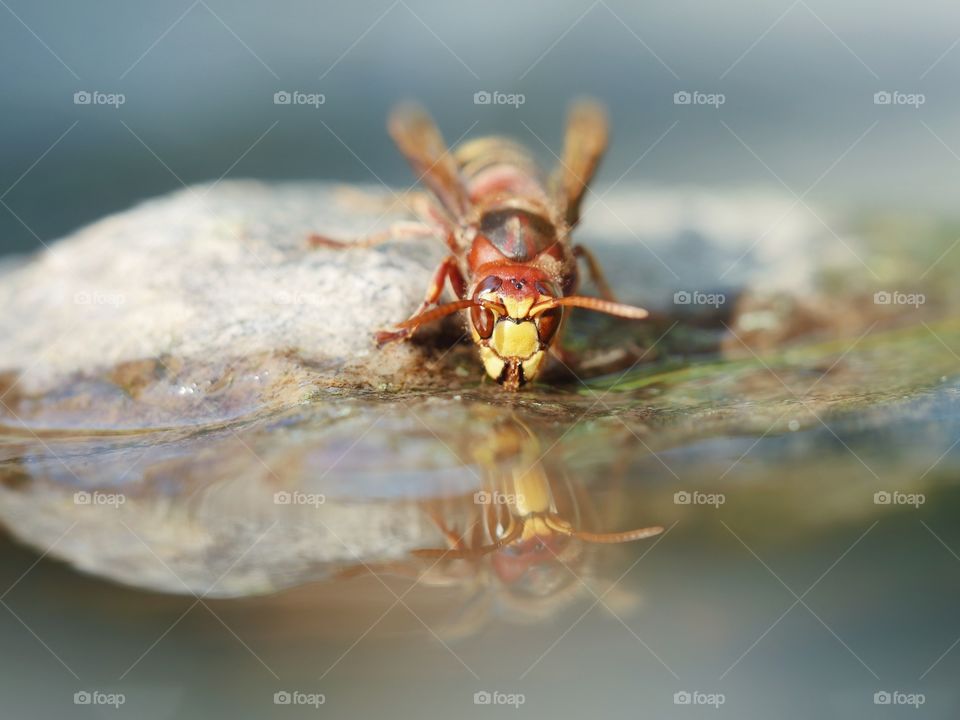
[0,0,960,252]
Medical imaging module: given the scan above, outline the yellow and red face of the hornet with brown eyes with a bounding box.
[470,276,563,390]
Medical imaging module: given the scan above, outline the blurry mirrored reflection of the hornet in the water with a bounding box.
[342,417,663,634]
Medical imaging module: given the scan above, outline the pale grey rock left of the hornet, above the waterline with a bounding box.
[0,182,448,426]
